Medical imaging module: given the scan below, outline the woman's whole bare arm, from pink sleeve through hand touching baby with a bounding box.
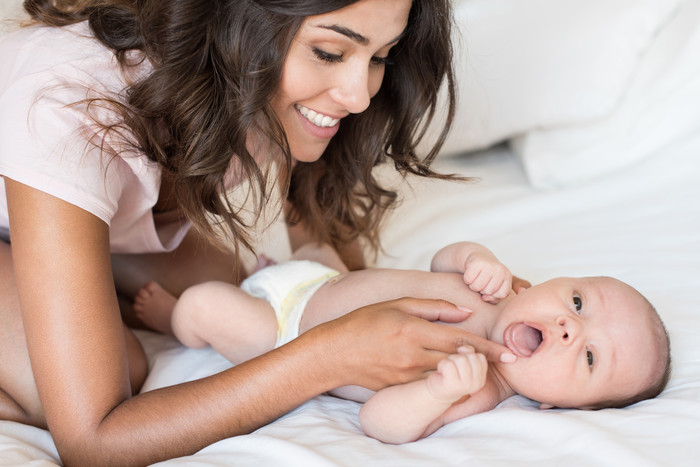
[5,179,507,465]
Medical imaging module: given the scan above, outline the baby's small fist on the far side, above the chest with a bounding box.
[464,251,513,303]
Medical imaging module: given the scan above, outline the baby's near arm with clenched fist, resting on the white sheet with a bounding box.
[360,347,488,444]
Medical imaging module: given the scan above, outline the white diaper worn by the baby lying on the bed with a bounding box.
[241,261,339,347]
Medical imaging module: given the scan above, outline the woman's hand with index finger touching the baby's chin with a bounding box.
[308,298,515,390]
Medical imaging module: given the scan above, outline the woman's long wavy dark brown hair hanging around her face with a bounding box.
[24,0,457,256]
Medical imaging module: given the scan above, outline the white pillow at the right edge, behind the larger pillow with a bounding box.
[511,0,700,188]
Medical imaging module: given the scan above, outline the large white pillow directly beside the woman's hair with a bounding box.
[429,0,681,157]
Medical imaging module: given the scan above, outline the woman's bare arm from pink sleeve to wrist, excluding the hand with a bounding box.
[6,180,348,465]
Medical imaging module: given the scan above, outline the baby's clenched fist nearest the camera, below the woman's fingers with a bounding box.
[426,346,488,403]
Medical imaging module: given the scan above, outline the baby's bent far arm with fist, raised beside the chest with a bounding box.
[430,242,513,302]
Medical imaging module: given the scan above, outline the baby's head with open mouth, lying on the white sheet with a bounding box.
[491,277,671,409]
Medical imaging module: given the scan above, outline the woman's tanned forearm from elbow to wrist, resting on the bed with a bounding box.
[66,330,337,465]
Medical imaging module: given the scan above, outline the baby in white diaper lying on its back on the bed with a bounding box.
[135,242,670,443]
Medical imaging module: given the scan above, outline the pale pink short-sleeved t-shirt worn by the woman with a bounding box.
[0,23,189,253]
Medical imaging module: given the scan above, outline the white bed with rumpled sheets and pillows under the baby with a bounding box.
[0,0,700,467]
